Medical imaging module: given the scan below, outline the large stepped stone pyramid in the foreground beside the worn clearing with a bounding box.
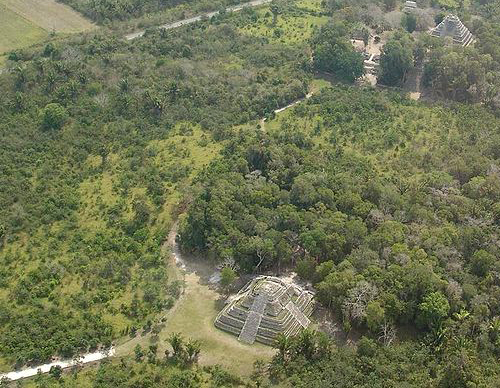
[215,276,314,345]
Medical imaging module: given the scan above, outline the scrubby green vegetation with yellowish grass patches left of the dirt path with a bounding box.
[0,14,308,365]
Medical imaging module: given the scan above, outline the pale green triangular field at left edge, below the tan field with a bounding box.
[0,0,48,54]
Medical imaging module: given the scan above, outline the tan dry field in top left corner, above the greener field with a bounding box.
[0,0,94,33]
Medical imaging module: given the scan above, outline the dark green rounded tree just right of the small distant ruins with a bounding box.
[379,36,413,86]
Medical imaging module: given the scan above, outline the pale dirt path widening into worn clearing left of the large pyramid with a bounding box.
[0,92,314,380]
